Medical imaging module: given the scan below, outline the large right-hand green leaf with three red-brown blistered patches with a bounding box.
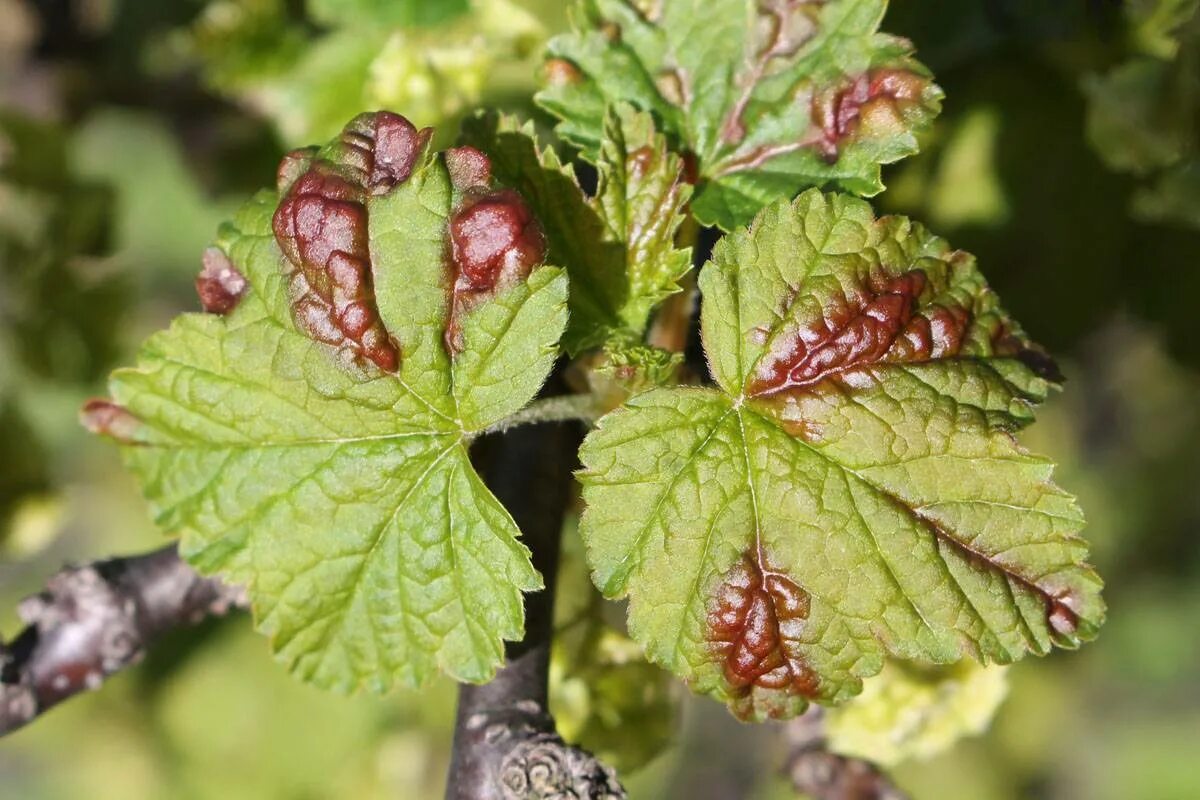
[580,191,1104,720]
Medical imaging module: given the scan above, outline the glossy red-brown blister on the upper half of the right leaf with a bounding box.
[749,270,971,397]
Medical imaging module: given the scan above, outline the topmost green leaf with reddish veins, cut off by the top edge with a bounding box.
[536,0,942,230]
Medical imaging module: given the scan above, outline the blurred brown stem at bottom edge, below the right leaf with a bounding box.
[784,705,908,800]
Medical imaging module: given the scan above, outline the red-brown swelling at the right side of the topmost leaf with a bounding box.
[812,70,929,163]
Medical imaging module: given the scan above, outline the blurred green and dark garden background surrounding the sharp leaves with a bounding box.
[0,0,1200,800]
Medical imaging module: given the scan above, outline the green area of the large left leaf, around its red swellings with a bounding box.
[110,130,566,691]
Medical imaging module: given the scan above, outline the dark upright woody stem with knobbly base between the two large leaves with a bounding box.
[445,425,625,800]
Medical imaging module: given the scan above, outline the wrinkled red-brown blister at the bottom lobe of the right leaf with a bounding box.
[707,555,820,718]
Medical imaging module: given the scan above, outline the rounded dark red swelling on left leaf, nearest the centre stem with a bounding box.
[445,185,546,355]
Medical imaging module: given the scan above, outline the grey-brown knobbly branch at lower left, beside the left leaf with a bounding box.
[0,545,246,735]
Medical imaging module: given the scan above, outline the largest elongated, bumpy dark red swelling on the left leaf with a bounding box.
[274,112,431,372]
